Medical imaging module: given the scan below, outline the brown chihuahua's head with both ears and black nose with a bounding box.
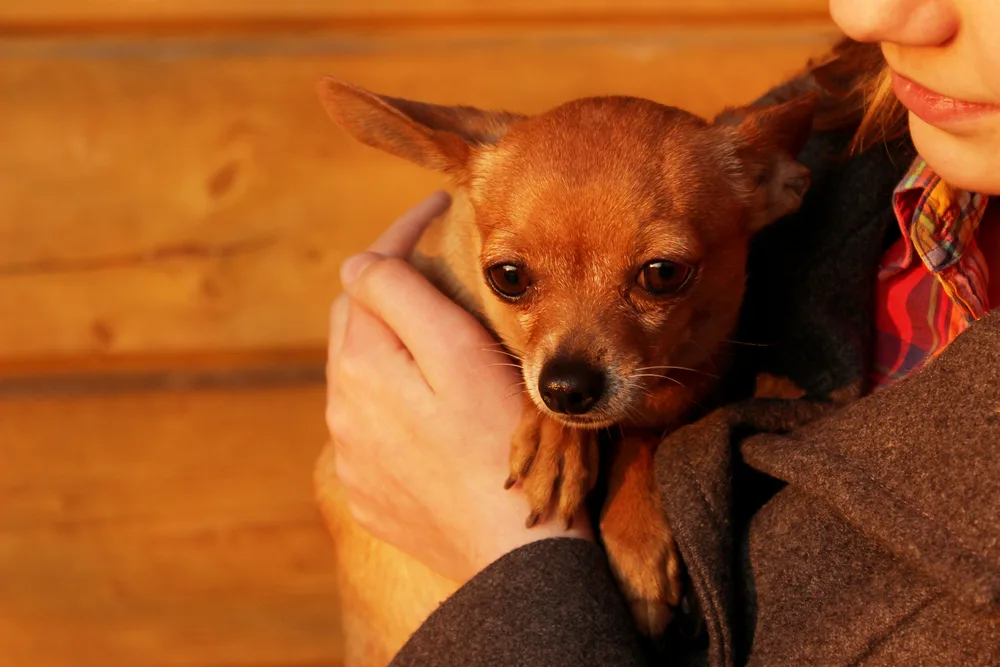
[320,79,814,428]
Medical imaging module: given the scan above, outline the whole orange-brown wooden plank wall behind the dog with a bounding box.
[0,5,835,667]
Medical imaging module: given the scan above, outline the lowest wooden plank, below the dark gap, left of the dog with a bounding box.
[0,385,341,667]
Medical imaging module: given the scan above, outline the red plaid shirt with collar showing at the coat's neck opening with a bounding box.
[871,158,990,387]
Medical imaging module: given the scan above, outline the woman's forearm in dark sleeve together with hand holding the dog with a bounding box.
[317,195,642,666]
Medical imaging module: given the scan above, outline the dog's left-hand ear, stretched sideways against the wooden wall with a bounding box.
[317,77,524,176]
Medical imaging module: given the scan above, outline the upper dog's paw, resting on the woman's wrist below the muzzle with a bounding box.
[504,409,598,528]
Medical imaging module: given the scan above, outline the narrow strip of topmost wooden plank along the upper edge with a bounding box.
[0,0,827,29]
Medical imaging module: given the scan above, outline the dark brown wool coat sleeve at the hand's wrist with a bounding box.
[391,538,647,667]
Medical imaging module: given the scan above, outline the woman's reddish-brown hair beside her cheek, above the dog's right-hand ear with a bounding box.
[767,39,908,153]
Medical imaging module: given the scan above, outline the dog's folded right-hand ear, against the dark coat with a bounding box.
[715,95,816,233]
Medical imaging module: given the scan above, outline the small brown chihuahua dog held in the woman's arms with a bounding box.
[319,78,814,664]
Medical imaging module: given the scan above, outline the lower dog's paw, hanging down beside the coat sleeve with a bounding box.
[601,506,683,637]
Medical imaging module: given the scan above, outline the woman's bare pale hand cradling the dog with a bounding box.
[317,193,590,582]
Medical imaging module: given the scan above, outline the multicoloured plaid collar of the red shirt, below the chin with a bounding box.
[882,157,989,275]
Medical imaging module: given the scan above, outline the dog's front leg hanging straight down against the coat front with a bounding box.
[601,434,681,636]
